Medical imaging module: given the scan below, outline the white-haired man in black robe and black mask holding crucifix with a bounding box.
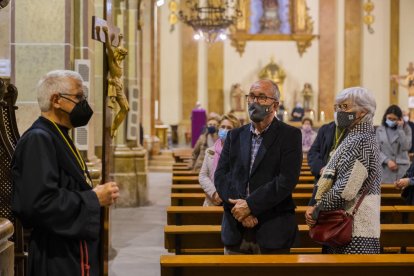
[12,70,119,276]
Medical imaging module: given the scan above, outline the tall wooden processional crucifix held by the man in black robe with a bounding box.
[92,0,129,276]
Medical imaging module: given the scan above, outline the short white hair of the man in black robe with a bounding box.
[36,70,83,112]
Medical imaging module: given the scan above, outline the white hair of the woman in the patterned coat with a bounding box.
[335,87,377,123]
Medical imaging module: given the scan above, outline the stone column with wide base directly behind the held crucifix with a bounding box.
[111,1,148,207]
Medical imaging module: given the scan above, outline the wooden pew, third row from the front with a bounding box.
[167,206,414,225]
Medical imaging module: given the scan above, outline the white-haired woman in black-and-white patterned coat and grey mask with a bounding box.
[305,87,382,254]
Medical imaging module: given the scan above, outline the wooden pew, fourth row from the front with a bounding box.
[171,193,405,206]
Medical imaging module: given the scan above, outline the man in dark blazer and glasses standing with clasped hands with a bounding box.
[214,80,302,254]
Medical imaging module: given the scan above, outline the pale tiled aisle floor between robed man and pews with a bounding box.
[109,173,171,276]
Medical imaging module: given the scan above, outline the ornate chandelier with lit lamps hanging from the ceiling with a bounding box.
[169,0,241,42]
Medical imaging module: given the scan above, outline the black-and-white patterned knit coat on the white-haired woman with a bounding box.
[315,122,382,254]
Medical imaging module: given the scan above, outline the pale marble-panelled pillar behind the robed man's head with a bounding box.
[11,0,74,133]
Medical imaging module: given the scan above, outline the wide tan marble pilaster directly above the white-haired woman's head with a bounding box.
[344,0,362,88]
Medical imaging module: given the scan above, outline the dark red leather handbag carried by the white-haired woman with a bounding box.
[309,190,367,247]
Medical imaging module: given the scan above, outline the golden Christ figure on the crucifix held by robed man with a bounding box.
[97,26,129,137]
